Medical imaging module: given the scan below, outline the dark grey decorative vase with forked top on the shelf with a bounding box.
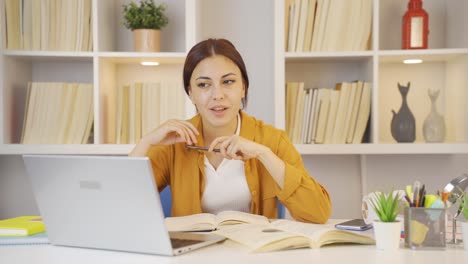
[391,82,416,142]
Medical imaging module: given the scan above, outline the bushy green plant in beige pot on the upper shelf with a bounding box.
[122,0,169,52]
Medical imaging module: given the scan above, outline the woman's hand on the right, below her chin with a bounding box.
[208,135,268,160]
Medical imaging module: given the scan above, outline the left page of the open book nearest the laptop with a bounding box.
[164,213,216,231]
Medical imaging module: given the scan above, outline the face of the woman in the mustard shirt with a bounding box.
[189,55,245,127]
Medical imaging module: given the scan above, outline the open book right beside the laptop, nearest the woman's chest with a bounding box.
[165,211,270,231]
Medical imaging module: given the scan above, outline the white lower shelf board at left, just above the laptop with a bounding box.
[0,144,134,155]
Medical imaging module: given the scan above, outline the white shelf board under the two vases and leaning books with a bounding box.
[295,143,468,155]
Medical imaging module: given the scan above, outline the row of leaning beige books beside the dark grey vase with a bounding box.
[286,81,371,144]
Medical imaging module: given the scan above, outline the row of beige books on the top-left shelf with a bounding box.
[5,0,93,51]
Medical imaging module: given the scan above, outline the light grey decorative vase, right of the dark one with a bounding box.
[423,90,445,142]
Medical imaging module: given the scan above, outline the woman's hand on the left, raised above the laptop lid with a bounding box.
[142,119,199,146]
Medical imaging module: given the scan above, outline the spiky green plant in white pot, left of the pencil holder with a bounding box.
[370,191,401,250]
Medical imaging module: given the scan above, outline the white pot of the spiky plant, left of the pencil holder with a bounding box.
[373,221,401,250]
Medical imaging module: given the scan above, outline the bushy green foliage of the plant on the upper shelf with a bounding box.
[122,0,169,30]
